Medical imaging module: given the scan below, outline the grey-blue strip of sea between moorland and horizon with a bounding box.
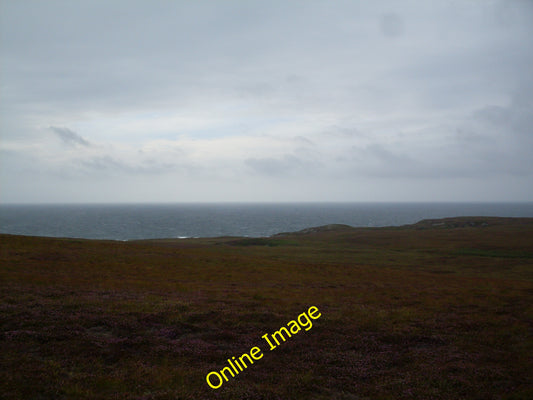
[0,203,533,240]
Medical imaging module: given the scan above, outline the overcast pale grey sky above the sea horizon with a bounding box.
[0,0,533,203]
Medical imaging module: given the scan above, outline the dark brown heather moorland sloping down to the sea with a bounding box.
[0,217,533,400]
